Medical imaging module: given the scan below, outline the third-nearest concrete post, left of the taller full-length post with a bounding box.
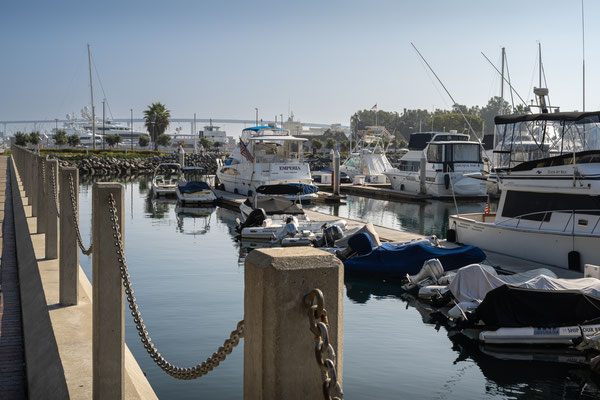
[58,168,79,306]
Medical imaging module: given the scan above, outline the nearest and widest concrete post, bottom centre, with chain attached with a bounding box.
[244,247,344,400]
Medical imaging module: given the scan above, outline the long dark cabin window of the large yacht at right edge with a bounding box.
[502,190,600,222]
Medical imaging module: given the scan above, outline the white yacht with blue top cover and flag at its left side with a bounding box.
[217,125,318,200]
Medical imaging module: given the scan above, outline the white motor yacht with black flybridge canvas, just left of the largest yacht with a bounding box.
[385,131,486,197]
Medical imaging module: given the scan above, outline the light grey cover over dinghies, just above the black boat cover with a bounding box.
[448,264,556,303]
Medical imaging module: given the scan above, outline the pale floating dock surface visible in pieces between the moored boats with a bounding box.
[214,190,583,278]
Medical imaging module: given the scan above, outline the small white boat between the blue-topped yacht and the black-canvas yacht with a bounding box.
[340,127,393,183]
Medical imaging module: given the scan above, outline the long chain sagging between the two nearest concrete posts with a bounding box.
[108,193,244,380]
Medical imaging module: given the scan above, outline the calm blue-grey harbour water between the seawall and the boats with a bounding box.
[80,180,600,399]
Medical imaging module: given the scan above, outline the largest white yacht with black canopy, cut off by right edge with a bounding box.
[449,112,600,270]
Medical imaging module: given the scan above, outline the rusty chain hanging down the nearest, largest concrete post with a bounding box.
[304,289,344,400]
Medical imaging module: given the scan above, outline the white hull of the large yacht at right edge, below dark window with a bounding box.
[449,214,600,268]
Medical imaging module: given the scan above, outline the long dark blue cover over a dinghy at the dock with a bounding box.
[344,243,486,277]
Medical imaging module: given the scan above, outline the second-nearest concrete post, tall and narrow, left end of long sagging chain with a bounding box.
[92,182,125,400]
